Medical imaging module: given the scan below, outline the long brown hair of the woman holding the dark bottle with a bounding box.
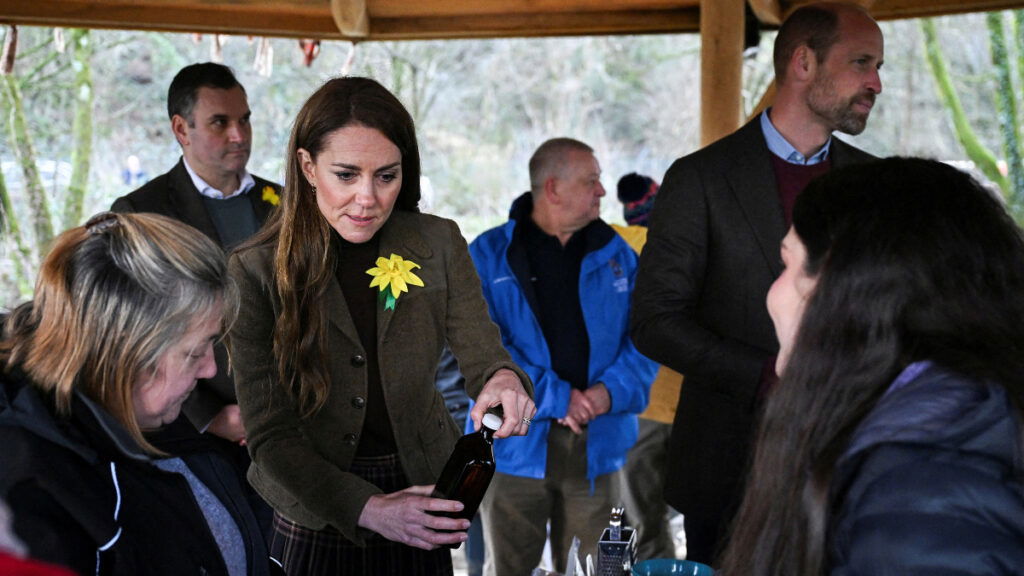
[242,77,420,415]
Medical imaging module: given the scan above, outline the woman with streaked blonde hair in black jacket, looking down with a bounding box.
[0,213,272,576]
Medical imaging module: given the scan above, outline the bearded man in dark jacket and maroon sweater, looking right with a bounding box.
[631,4,883,563]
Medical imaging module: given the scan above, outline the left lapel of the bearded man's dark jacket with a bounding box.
[723,118,785,276]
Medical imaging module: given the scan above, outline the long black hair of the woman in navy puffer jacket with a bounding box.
[720,158,1024,576]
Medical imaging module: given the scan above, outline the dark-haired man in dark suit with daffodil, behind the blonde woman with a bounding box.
[111,63,280,444]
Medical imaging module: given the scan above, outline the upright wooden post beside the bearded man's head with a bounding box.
[700,0,743,146]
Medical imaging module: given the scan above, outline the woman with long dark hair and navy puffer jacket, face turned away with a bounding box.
[720,154,1024,576]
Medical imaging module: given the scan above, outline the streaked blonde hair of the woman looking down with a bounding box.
[0,212,238,453]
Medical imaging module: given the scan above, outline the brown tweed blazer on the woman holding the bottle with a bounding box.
[229,211,532,543]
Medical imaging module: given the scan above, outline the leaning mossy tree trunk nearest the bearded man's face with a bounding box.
[921,18,1011,192]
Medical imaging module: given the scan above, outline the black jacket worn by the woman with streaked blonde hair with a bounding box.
[0,366,276,576]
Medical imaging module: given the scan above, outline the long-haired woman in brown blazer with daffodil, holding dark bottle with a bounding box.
[229,78,536,576]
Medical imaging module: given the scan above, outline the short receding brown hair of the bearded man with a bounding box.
[773,4,840,81]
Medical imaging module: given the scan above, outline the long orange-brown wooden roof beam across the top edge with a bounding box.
[6,0,1024,40]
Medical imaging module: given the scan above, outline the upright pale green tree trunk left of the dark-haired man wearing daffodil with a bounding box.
[61,30,93,229]
